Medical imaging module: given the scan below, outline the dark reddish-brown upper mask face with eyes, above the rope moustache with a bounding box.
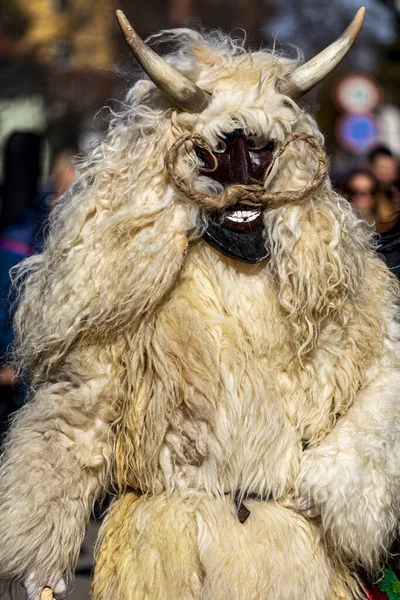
[195,129,274,187]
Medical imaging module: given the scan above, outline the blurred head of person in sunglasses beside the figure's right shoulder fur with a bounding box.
[345,169,378,225]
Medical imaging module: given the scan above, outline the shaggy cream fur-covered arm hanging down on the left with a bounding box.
[0,356,115,598]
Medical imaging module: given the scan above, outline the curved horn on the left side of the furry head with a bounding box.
[116,10,210,113]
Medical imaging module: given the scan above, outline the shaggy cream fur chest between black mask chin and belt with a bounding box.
[115,245,366,498]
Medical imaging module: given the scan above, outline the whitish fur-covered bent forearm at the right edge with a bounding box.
[297,346,400,569]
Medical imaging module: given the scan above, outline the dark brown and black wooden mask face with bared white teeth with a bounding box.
[195,129,274,263]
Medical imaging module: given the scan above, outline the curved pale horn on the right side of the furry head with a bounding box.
[282,7,365,98]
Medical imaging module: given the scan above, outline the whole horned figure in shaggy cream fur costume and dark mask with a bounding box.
[0,9,400,600]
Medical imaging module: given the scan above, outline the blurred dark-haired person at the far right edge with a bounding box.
[368,146,400,233]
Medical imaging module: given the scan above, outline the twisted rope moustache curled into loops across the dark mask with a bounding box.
[165,133,328,211]
